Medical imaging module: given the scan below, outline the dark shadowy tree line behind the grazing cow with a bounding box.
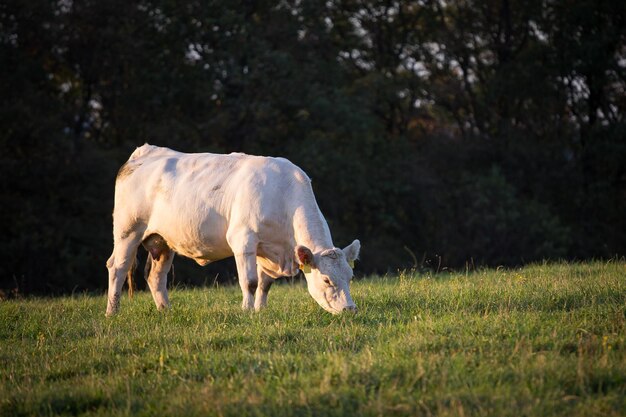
[0,0,626,294]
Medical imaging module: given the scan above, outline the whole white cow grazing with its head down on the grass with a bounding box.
[106,144,361,316]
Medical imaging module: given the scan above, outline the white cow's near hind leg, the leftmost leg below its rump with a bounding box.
[106,232,141,316]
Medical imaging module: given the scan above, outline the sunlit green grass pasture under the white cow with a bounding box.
[0,262,626,417]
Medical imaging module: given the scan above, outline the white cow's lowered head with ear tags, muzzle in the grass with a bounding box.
[296,240,361,314]
